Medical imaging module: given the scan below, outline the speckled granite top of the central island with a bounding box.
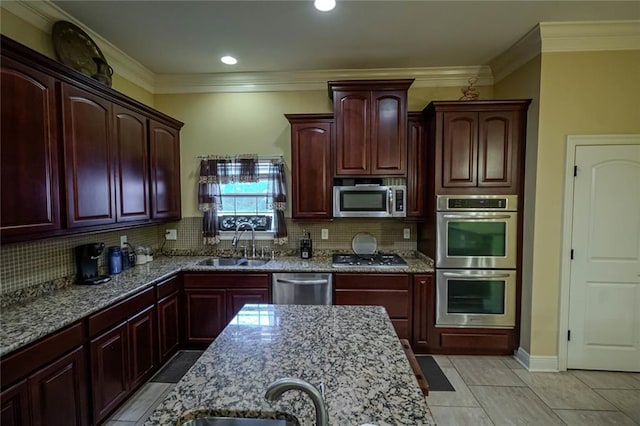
[145,305,434,426]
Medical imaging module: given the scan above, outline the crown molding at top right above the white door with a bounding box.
[540,20,640,53]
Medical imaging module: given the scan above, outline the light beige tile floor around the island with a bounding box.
[107,355,640,426]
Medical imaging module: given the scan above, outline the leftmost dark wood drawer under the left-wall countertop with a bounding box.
[0,323,84,389]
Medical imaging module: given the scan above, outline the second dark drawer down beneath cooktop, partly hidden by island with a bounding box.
[335,290,410,319]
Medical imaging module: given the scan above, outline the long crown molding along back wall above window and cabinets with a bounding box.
[156,66,493,94]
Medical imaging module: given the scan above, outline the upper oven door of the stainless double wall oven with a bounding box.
[436,212,518,269]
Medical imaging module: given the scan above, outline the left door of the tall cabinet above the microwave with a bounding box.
[333,90,371,176]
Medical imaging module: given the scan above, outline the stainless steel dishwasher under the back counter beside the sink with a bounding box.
[271,272,333,305]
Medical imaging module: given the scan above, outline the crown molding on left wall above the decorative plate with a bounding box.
[2,0,156,93]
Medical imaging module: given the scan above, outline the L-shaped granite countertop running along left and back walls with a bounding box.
[0,256,433,356]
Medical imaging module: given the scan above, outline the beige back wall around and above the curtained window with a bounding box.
[155,87,480,217]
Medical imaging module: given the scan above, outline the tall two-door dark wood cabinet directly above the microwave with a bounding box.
[328,79,413,176]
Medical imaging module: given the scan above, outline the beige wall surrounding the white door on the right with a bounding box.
[530,50,640,356]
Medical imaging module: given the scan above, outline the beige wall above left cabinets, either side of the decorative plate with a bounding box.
[0,7,153,106]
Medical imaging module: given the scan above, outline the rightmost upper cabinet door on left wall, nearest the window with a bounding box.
[149,120,182,219]
